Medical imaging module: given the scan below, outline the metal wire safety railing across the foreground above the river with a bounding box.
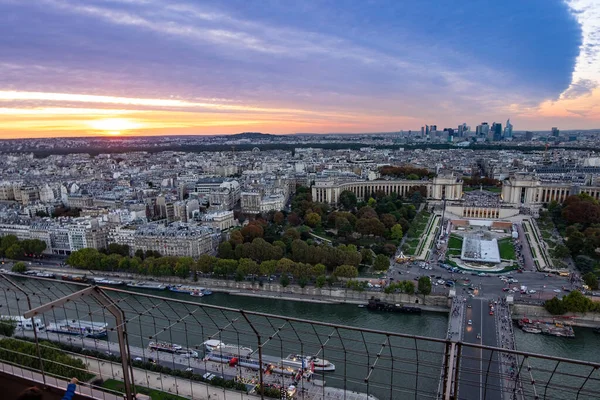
[0,275,600,400]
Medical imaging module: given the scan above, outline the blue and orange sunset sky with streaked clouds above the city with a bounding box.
[0,0,600,138]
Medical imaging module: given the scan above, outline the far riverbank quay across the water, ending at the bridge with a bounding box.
[21,267,450,313]
